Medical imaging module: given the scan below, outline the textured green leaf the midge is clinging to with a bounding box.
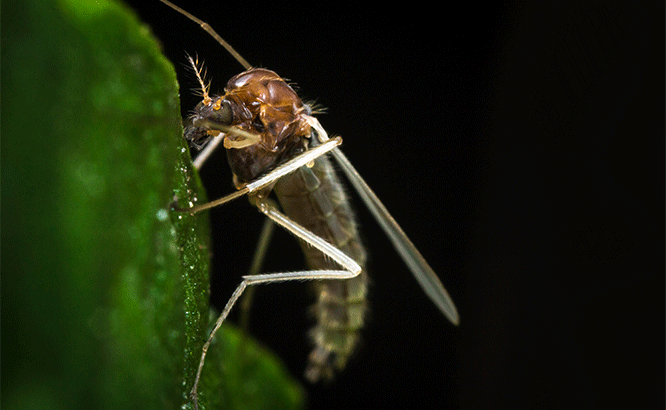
[1,0,303,409]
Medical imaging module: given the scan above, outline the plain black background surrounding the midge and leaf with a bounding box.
[126,0,665,409]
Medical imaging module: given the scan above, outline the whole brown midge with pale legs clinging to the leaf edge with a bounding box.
[160,0,459,407]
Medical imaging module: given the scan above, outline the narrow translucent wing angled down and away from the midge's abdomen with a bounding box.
[331,148,460,325]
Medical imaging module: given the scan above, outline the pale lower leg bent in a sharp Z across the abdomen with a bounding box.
[190,198,361,409]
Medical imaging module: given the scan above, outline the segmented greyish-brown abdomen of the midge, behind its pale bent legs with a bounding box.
[274,152,368,382]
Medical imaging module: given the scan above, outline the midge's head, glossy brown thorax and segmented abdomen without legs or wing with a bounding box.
[186,68,368,382]
